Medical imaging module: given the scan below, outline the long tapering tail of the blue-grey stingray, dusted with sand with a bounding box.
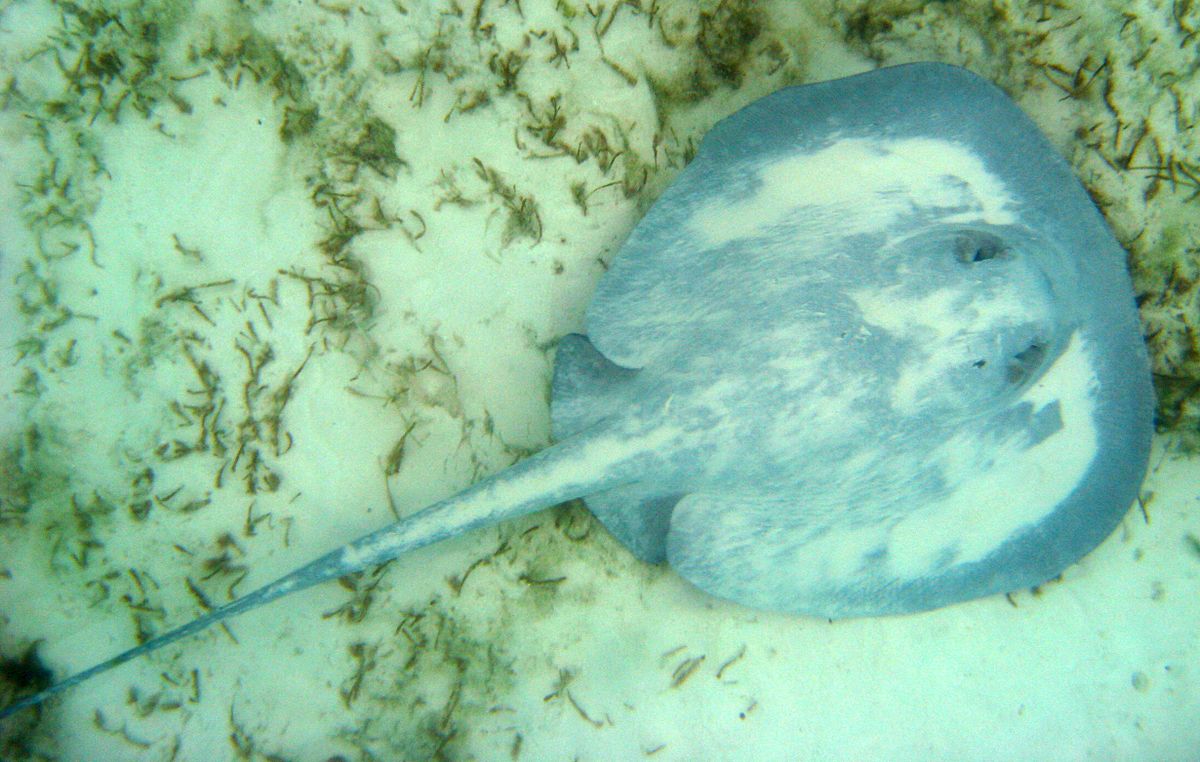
[0,432,641,720]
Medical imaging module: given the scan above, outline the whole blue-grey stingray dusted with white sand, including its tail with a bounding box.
[0,64,1153,716]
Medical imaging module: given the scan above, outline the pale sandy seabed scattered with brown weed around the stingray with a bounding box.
[0,0,1200,761]
